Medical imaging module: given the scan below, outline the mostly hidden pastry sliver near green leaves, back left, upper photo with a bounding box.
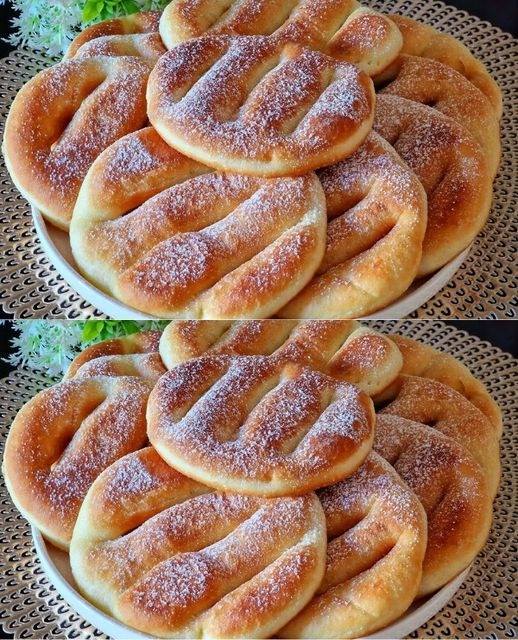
[65,11,161,60]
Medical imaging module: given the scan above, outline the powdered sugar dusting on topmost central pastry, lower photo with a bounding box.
[150,357,372,481]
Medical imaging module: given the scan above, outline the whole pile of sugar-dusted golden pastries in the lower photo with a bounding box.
[3,320,502,638]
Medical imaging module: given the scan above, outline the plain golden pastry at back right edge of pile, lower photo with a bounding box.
[382,334,502,438]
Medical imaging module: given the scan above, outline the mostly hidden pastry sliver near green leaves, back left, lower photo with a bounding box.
[64,331,162,380]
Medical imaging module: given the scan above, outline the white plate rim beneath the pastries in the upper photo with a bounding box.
[32,207,471,320]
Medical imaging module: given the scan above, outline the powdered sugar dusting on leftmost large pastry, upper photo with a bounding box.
[19,58,149,215]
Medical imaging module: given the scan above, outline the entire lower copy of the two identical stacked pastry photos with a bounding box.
[0,320,518,640]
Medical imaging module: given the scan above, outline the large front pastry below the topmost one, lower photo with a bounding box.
[70,448,326,638]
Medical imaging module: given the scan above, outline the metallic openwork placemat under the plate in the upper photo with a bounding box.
[0,0,518,318]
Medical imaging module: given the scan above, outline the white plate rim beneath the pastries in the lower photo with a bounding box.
[32,527,471,640]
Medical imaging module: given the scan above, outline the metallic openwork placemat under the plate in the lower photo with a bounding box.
[0,320,518,640]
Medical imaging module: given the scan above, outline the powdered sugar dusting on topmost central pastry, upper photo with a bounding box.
[150,36,373,160]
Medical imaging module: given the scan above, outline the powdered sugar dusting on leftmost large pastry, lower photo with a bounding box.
[19,378,149,539]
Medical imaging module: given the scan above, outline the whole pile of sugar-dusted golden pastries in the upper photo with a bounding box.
[3,0,502,319]
